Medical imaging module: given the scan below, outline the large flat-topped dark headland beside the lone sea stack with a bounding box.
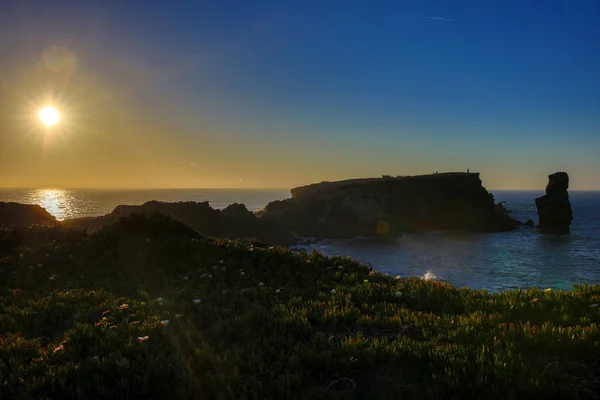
[260,173,520,237]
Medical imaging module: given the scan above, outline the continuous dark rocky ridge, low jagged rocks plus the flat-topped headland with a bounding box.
[64,173,520,244]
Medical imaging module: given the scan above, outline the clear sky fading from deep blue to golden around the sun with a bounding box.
[0,0,600,189]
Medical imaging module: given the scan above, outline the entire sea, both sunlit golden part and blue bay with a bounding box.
[0,189,600,291]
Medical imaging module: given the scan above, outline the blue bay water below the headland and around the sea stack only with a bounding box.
[296,191,600,291]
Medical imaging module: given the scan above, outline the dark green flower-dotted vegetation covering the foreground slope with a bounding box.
[0,216,600,400]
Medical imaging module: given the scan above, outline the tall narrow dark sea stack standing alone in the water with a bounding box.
[535,172,573,233]
